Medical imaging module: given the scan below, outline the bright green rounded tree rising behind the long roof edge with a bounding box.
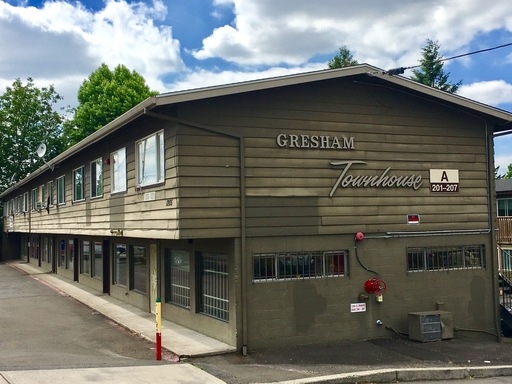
[64,64,158,145]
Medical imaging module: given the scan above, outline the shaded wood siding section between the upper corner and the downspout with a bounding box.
[177,126,240,238]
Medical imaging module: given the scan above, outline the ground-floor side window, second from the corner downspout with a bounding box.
[165,249,190,308]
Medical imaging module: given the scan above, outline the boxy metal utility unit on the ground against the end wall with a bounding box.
[408,311,453,342]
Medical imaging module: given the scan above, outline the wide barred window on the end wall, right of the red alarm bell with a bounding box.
[407,245,485,272]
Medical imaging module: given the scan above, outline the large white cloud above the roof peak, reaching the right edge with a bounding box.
[194,0,512,68]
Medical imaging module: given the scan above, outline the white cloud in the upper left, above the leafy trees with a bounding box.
[0,0,185,105]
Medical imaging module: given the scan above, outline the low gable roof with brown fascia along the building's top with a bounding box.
[0,64,512,198]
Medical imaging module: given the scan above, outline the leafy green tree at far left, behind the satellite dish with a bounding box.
[0,77,63,191]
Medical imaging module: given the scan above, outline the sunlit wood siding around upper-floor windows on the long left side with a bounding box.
[5,118,179,238]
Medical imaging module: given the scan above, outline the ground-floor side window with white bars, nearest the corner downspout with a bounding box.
[199,253,229,321]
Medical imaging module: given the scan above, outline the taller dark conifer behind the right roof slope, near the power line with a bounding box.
[411,39,462,93]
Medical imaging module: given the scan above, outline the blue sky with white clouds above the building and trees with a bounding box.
[0,0,512,173]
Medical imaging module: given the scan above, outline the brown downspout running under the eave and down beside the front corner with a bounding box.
[144,108,248,356]
